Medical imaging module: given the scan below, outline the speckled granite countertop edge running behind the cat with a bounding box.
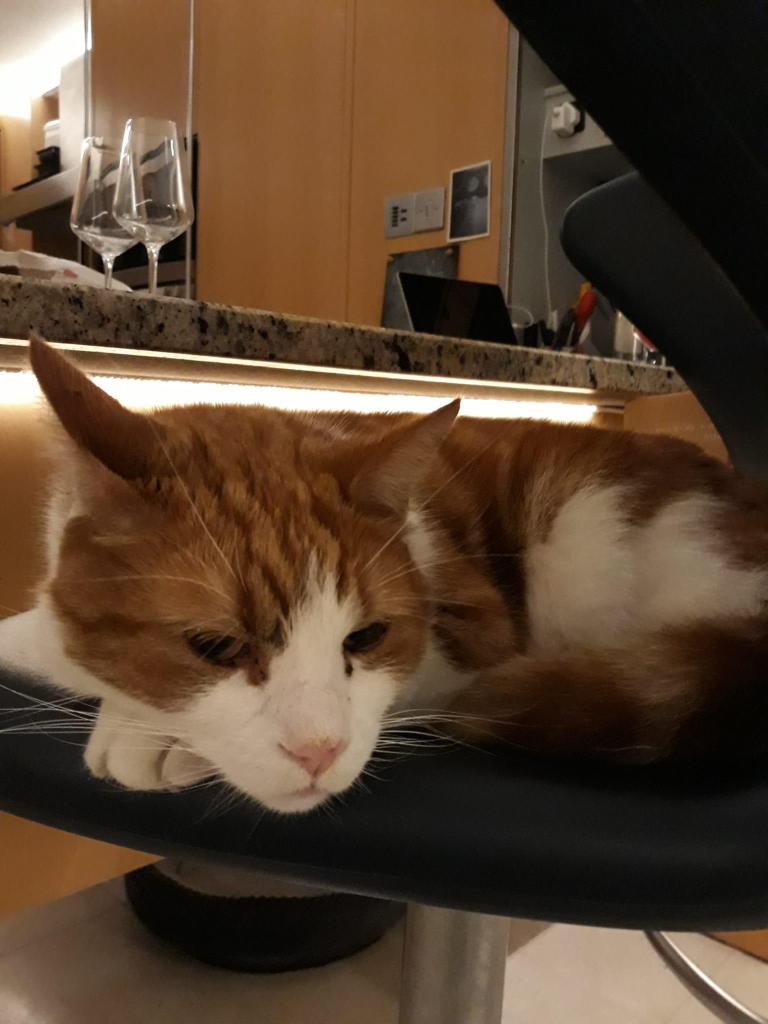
[0,274,685,397]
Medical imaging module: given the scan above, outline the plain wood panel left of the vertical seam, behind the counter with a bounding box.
[196,0,353,319]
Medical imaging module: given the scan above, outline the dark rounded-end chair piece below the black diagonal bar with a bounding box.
[562,173,768,478]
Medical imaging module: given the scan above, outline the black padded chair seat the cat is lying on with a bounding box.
[0,672,768,930]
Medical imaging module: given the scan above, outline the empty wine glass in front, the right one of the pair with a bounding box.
[114,118,195,295]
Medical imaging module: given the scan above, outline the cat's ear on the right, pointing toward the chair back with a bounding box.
[350,398,461,517]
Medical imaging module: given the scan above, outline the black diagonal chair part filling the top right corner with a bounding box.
[497,0,768,328]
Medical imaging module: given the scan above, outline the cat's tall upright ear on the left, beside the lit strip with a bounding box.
[30,337,160,480]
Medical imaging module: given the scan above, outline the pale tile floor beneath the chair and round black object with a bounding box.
[0,885,768,1024]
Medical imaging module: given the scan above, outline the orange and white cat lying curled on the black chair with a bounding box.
[0,340,768,812]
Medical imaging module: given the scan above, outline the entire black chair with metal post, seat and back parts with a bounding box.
[0,0,768,1024]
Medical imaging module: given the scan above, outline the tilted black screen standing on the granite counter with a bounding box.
[398,271,517,345]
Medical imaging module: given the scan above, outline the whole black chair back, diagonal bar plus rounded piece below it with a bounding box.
[497,0,768,477]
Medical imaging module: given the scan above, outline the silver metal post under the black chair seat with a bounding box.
[399,904,509,1024]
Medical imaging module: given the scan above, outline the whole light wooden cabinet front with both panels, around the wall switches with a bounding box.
[191,0,508,325]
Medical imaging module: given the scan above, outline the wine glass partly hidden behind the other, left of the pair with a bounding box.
[70,136,136,288]
